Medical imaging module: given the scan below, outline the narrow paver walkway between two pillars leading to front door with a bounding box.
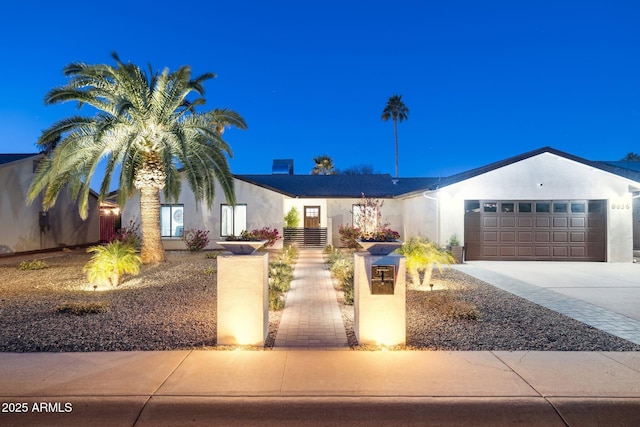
[274,249,349,350]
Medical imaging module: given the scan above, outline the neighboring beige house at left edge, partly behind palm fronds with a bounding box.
[0,154,99,254]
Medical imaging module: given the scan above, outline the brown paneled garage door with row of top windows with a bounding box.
[464,200,607,261]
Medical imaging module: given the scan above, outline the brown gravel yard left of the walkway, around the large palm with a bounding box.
[0,249,280,352]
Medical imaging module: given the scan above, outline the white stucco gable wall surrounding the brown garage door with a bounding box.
[430,153,637,262]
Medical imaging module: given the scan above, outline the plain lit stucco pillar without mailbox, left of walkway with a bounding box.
[216,252,269,346]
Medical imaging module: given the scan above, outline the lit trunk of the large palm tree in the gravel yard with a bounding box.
[140,187,165,264]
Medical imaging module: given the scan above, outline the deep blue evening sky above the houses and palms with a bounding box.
[0,0,640,187]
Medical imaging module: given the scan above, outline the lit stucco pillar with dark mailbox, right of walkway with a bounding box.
[353,252,407,346]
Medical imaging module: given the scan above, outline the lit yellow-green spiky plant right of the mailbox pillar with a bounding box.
[397,236,455,286]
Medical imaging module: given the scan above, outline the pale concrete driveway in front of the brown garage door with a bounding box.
[460,261,640,321]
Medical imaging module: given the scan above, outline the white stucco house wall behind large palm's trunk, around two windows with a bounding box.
[122,179,284,250]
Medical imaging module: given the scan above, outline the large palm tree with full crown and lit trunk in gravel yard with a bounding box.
[28,53,246,264]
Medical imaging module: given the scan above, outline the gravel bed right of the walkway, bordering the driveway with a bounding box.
[338,269,640,351]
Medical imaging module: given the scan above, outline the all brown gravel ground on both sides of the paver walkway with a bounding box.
[0,249,640,352]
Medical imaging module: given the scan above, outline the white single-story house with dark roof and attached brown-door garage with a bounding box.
[122,147,640,262]
